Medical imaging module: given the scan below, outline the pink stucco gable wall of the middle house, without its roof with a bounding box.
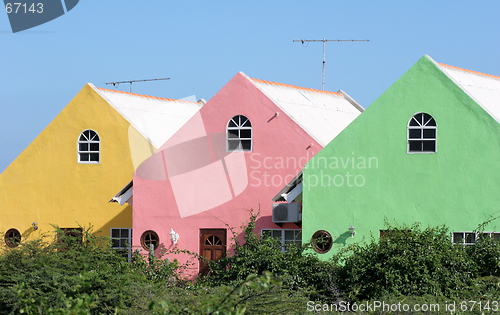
[133,74,321,276]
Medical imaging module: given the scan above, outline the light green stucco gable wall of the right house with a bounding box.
[302,56,500,258]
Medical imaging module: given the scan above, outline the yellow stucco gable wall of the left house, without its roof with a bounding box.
[0,85,147,245]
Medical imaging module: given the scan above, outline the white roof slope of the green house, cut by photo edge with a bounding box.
[429,57,500,123]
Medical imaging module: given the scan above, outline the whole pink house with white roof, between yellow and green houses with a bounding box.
[129,72,363,273]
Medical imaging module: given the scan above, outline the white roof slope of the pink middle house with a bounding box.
[246,73,363,147]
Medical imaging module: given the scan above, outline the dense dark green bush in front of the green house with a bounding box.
[332,224,500,300]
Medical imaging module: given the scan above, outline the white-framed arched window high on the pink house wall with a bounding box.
[226,115,252,151]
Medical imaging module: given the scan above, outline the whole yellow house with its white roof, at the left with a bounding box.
[0,84,204,256]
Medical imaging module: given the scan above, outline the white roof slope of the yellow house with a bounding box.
[89,83,204,148]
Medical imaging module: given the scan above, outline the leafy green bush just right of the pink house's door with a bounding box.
[202,211,335,302]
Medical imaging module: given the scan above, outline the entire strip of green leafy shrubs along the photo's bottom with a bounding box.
[0,213,500,315]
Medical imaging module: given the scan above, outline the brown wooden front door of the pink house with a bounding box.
[200,229,226,276]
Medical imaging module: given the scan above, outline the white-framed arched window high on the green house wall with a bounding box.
[408,113,437,153]
